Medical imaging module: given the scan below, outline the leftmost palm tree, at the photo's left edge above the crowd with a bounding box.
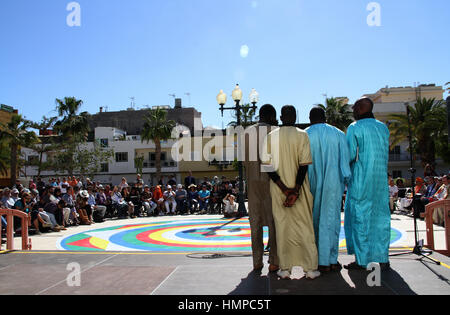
[0,114,38,186]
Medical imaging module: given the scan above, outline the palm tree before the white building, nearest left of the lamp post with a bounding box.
[141,108,176,181]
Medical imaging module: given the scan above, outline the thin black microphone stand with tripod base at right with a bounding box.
[389,103,441,265]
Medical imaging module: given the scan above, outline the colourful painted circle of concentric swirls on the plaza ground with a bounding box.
[58,218,402,253]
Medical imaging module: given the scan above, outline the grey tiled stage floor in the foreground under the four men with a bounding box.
[0,249,450,297]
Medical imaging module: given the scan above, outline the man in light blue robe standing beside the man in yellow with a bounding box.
[306,107,351,272]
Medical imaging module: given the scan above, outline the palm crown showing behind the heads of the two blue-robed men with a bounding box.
[318,97,353,132]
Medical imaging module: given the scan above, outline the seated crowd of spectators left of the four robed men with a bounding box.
[0,172,243,235]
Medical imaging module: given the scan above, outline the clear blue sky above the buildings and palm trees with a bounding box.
[0,0,450,127]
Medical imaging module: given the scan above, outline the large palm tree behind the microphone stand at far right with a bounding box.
[389,98,447,172]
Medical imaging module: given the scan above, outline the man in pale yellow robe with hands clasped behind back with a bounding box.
[262,106,320,279]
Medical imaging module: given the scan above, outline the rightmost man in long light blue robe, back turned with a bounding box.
[345,98,391,270]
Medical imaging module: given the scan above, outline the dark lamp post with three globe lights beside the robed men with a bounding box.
[217,84,259,218]
